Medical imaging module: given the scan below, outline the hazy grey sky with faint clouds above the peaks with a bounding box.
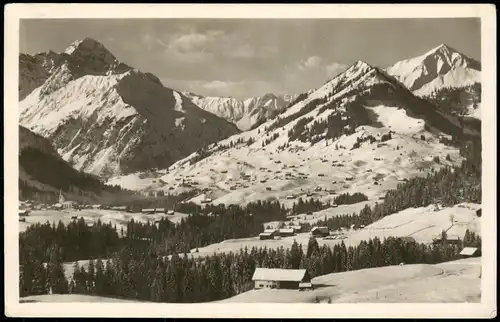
[20,18,481,98]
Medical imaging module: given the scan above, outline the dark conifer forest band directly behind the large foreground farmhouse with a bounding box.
[20,232,481,303]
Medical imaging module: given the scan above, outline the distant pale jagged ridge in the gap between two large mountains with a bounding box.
[183,92,297,131]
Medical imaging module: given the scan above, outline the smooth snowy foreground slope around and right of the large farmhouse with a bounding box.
[219,257,481,303]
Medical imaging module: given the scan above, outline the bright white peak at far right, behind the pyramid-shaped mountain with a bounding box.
[386,44,481,96]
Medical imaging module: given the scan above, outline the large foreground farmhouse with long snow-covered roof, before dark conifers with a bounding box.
[252,268,312,289]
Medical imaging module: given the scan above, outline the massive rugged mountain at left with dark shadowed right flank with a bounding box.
[20,38,239,177]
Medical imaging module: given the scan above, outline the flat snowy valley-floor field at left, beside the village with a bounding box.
[19,209,189,232]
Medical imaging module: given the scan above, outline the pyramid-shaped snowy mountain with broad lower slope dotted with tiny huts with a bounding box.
[108,61,480,205]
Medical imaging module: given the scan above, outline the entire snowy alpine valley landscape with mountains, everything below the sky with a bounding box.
[19,38,482,303]
